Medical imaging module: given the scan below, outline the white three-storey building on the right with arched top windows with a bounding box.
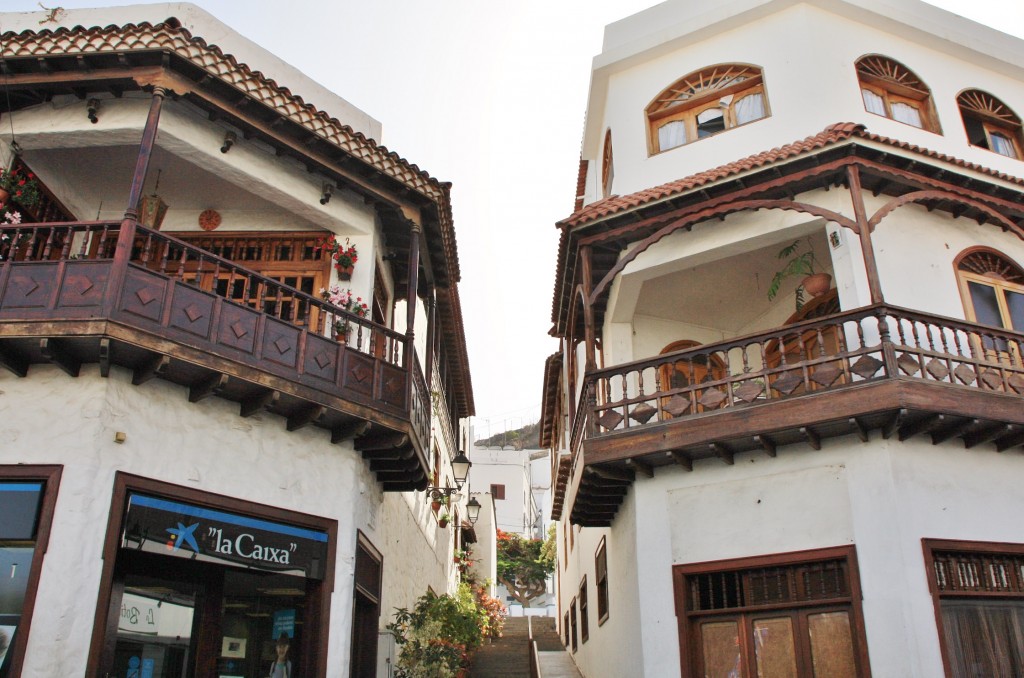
[542,0,1024,678]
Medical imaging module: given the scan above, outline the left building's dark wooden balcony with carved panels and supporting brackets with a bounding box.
[0,221,430,491]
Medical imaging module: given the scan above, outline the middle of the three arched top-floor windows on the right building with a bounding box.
[857,54,941,132]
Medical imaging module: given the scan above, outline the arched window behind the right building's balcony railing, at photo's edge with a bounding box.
[956,248,1024,332]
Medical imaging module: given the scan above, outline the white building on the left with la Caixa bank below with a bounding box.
[0,4,473,678]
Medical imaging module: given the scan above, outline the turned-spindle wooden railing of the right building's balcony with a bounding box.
[573,305,1024,438]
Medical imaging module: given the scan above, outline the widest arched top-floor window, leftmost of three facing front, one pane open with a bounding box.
[647,63,769,154]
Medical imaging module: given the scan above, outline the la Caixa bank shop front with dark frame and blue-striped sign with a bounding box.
[90,474,336,678]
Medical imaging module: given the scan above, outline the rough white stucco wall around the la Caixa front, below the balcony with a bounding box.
[0,365,452,678]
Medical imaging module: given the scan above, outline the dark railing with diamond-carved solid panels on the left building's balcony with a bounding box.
[0,221,430,475]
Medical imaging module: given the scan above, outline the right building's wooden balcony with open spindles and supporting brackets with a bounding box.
[566,305,1024,525]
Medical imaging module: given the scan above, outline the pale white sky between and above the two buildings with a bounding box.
[0,0,1024,436]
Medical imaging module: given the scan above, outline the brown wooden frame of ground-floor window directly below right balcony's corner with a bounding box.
[672,546,871,678]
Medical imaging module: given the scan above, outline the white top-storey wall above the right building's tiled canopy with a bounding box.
[583,0,1024,204]
